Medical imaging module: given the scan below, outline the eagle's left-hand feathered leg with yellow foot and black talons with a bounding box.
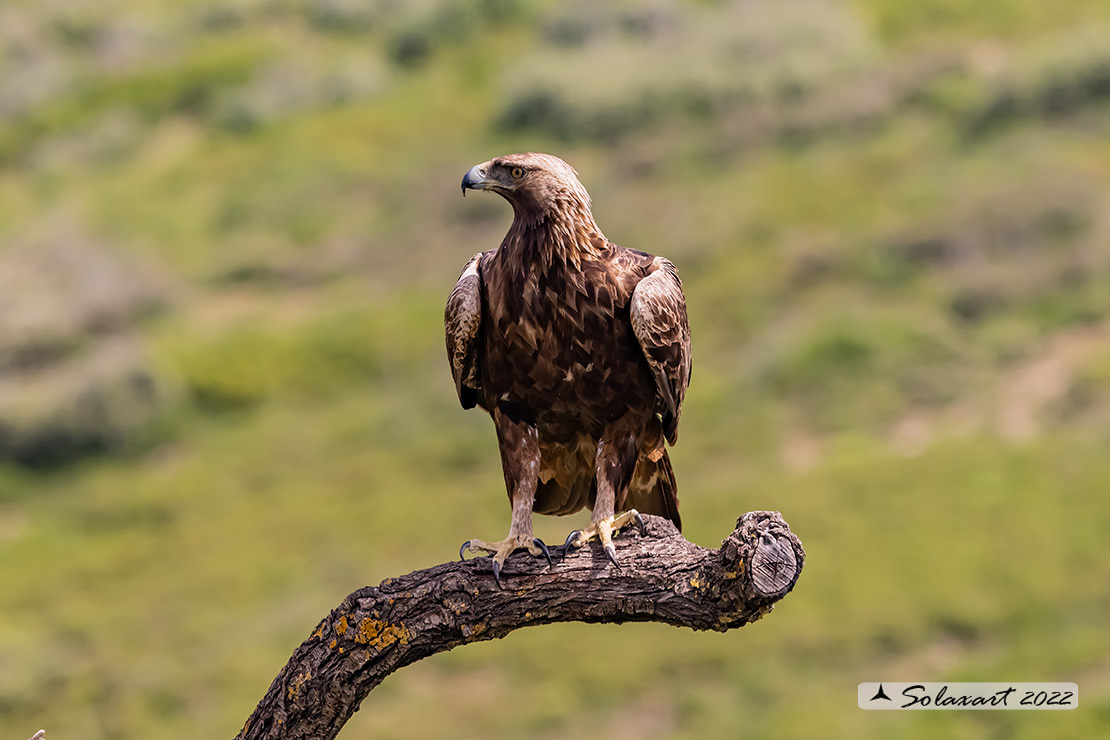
[458,409,552,586]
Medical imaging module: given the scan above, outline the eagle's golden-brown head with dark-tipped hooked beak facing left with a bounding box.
[463,152,589,216]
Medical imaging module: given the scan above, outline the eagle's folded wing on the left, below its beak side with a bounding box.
[443,252,482,408]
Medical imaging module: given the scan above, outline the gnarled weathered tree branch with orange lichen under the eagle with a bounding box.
[238,511,805,740]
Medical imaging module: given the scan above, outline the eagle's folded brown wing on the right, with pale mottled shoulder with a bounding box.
[629,257,692,445]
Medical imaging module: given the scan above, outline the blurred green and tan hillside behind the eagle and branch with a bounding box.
[0,0,1110,740]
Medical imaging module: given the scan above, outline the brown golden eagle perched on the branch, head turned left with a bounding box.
[444,153,690,586]
